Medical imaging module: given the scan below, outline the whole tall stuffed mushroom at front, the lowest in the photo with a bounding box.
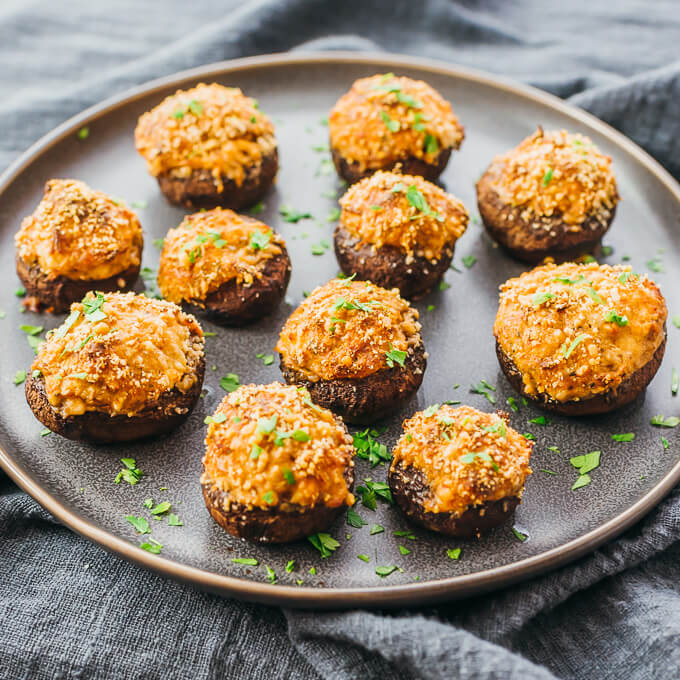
[201,383,354,543]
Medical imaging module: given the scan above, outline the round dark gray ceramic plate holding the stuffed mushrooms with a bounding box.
[0,53,680,607]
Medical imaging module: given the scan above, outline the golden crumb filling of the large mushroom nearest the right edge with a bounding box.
[494,263,668,401]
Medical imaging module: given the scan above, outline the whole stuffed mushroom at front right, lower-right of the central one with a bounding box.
[389,404,533,537]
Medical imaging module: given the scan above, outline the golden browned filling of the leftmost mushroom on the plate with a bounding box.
[15,179,144,281]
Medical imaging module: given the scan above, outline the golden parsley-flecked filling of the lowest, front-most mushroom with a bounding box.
[201,383,354,509]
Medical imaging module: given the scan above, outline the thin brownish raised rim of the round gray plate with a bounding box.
[0,51,680,609]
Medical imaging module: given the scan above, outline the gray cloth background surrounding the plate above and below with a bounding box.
[0,1,680,678]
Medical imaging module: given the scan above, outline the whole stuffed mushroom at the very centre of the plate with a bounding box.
[276,279,427,423]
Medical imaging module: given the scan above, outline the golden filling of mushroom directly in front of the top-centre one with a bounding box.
[340,171,468,260]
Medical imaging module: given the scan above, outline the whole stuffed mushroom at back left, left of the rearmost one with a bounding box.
[135,83,278,210]
